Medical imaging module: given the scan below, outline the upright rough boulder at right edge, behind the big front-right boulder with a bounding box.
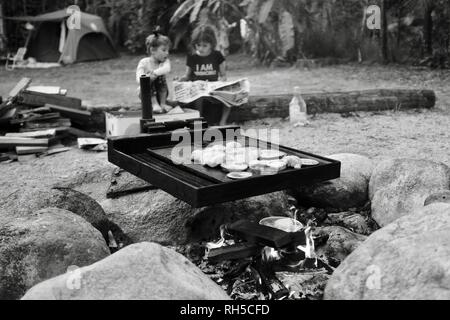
[369,159,450,226]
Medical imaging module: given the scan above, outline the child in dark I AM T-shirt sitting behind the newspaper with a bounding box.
[179,25,231,125]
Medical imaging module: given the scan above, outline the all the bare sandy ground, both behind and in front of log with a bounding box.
[0,56,450,204]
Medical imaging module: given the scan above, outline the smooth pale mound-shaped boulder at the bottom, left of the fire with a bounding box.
[23,243,229,300]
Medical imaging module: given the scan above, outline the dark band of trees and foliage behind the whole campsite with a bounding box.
[3,0,450,67]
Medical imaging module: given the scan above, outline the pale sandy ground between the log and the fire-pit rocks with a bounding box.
[0,107,450,204]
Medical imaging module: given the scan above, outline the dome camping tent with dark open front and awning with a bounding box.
[7,10,118,64]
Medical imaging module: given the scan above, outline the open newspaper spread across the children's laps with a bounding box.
[173,79,250,107]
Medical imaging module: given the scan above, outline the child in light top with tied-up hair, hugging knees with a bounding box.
[136,31,172,113]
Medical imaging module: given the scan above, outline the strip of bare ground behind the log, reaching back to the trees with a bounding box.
[0,54,450,110]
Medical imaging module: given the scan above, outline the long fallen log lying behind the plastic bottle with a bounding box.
[230,89,436,122]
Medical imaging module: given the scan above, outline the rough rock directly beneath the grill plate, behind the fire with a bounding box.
[101,190,289,245]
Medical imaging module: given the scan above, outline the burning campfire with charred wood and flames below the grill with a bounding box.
[204,210,334,300]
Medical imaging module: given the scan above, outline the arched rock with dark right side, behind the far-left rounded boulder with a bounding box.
[0,188,131,247]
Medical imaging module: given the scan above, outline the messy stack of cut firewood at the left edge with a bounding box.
[0,78,102,162]
